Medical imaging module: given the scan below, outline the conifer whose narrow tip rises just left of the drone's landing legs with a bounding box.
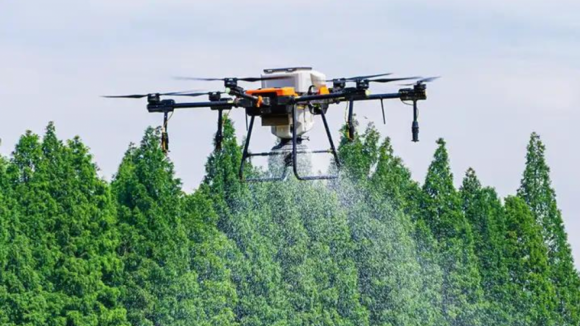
[201,117,294,326]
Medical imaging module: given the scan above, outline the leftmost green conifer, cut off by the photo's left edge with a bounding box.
[0,132,50,325]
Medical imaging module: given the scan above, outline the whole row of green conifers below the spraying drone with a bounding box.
[0,119,580,326]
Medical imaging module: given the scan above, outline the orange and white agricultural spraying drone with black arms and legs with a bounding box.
[104,67,439,182]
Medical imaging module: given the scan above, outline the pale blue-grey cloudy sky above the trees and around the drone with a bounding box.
[0,0,580,267]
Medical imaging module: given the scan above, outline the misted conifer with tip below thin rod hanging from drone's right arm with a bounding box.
[371,138,445,325]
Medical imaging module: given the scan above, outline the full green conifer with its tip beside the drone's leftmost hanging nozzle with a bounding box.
[112,128,207,325]
